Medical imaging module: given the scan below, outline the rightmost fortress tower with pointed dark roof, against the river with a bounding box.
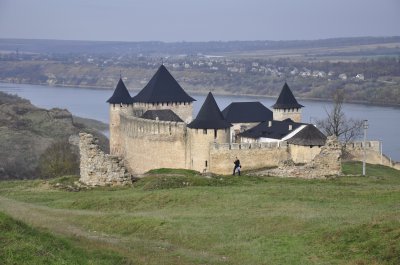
[272,82,304,122]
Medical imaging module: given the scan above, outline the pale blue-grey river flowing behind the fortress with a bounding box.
[0,83,400,161]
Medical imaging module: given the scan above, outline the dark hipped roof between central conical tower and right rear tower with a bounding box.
[222,102,272,123]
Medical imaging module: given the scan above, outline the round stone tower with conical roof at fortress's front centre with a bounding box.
[187,92,232,172]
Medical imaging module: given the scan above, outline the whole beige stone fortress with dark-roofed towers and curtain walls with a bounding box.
[100,65,326,175]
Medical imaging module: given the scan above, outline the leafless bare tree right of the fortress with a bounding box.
[317,89,363,146]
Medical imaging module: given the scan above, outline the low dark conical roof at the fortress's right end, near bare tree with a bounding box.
[287,124,326,146]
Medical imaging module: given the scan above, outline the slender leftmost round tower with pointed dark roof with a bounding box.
[107,78,133,155]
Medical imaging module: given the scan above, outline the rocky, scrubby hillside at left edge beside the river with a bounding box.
[0,92,108,179]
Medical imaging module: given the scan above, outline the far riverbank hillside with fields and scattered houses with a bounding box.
[0,40,400,104]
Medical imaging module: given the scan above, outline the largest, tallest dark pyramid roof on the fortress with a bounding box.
[133,65,195,103]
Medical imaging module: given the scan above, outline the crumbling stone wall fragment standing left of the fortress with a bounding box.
[79,133,132,186]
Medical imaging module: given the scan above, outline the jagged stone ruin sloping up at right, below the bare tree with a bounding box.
[259,136,342,179]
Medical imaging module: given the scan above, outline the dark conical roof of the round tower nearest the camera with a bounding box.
[188,92,232,129]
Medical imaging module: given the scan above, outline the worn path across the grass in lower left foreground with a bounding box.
[0,196,221,264]
